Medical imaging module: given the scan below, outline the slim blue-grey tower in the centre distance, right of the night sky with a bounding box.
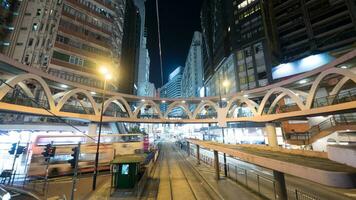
[182,31,203,97]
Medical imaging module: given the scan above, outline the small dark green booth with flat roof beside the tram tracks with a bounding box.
[111,154,146,189]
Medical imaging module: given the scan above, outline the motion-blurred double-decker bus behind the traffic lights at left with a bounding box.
[27,134,144,177]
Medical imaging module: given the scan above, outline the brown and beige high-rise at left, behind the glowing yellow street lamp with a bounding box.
[0,0,140,92]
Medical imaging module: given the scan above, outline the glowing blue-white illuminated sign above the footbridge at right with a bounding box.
[272,53,335,79]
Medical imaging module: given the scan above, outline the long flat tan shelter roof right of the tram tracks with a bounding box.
[187,139,356,188]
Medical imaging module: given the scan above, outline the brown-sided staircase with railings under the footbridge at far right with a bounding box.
[285,114,356,145]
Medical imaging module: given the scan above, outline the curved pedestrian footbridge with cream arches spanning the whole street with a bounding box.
[0,51,356,126]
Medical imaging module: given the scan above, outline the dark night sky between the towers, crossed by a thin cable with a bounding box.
[146,0,203,88]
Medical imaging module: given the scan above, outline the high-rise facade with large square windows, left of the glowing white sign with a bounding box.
[230,0,275,91]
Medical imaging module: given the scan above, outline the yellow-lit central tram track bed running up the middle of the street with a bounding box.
[140,143,224,200]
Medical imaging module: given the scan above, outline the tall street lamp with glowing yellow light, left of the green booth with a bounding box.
[92,66,112,190]
